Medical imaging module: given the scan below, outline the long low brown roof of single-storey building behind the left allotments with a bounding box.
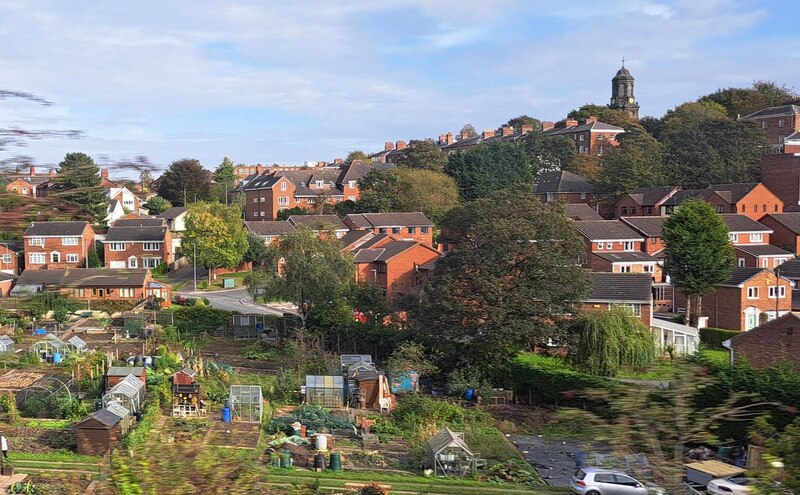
[17,268,149,287]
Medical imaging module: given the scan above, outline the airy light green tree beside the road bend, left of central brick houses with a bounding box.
[245,226,355,327]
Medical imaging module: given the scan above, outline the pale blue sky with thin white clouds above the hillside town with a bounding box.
[0,0,800,175]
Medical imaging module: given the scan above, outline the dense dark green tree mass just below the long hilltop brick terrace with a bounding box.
[444,143,536,201]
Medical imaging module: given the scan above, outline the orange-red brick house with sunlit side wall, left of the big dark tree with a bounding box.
[352,233,441,298]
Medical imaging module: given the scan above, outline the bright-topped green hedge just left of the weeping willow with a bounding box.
[511,353,612,403]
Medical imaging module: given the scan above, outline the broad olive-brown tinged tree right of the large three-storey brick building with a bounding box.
[355,167,459,223]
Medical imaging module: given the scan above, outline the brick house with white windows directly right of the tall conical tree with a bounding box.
[720,214,794,269]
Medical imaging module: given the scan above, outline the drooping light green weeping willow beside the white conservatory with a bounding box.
[572,306,656,376]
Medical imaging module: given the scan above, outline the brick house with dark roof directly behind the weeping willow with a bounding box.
[581,272,653,328]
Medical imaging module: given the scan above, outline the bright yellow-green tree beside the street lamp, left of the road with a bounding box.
[181,202,249,284]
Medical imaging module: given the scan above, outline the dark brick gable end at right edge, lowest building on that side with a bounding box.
[725,313,800,372]
